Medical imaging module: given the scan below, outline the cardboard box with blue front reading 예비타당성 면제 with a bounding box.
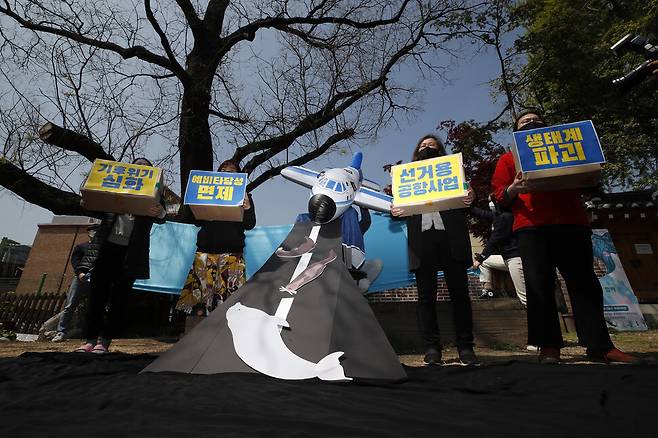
[184,170,247,222]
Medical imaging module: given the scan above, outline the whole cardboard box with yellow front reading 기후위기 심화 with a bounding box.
[80,160,162,216]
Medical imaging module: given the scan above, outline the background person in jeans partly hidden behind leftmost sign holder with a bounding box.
[52,226,98,342]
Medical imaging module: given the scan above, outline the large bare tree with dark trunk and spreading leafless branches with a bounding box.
[0,0,482,219]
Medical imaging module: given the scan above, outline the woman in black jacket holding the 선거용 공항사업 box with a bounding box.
[391,135,477,365]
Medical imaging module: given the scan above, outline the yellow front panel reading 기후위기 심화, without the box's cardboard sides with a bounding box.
[83,160,160,197]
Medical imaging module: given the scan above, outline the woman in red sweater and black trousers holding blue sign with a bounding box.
[491,109,637,363]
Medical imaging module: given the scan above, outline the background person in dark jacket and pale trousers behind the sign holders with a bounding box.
[471,197,526,307]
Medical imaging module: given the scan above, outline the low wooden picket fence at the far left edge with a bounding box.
[0,292,66,334]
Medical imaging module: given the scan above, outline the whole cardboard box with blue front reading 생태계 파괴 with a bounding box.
[512,120,605,192]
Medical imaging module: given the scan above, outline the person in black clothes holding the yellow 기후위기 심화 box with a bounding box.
[75,158,166,353]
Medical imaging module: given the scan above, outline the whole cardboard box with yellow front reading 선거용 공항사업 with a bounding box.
[391,153,468,216]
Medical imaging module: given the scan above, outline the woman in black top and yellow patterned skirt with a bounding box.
[176,160,256,316]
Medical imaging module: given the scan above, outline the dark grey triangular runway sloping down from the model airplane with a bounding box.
[145,220,406,381]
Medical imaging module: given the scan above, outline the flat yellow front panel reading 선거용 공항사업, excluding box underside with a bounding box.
[391,153,464,205]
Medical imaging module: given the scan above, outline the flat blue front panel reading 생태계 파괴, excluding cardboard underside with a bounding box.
[514,120,605,172]
